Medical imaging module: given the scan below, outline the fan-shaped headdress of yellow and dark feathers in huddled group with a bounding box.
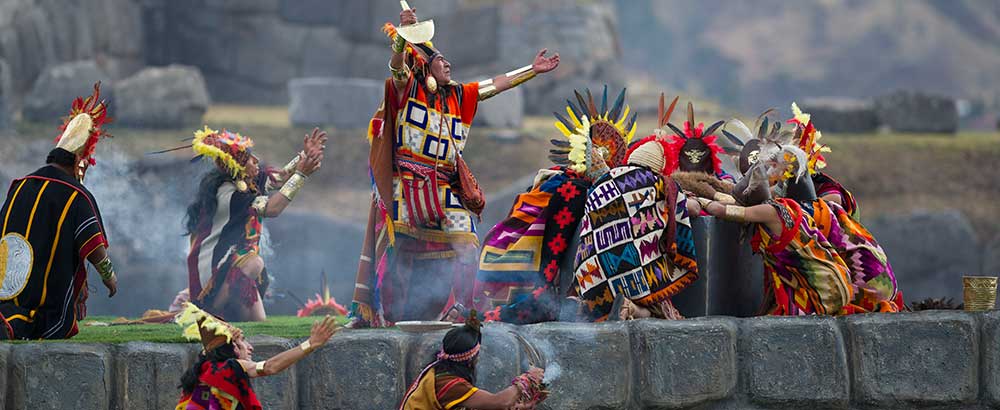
[549,85,637,173]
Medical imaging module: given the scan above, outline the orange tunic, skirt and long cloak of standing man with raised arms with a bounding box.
[350,74,479,327]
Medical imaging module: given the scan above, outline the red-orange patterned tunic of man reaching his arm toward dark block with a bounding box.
[752,198,854,316]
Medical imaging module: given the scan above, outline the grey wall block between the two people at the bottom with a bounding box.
[296,330,408,410]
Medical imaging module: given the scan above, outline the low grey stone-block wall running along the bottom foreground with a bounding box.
[0,311,1000,410]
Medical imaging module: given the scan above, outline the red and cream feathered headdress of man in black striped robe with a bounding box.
[55,81,111,165]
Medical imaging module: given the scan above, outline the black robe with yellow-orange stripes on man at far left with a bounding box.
[0,166,108,339]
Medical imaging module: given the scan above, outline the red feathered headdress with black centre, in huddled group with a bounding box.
[666,102,725,175]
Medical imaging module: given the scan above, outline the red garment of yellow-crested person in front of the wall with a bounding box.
[175,359,263,410]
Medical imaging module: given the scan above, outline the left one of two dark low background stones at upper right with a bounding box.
[799,98,879,133]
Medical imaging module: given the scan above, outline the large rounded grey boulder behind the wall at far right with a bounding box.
[866,210,983,301]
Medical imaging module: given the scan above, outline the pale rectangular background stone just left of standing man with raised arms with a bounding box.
[288,77,384,129]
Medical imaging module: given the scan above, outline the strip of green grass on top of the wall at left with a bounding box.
[45,316,347,344]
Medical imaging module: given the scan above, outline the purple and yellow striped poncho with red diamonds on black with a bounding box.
[475,168,590,324]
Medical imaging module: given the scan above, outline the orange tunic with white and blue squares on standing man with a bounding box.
[392,79,479,243]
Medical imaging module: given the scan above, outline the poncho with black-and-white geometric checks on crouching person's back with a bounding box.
[575,166,698,320]
